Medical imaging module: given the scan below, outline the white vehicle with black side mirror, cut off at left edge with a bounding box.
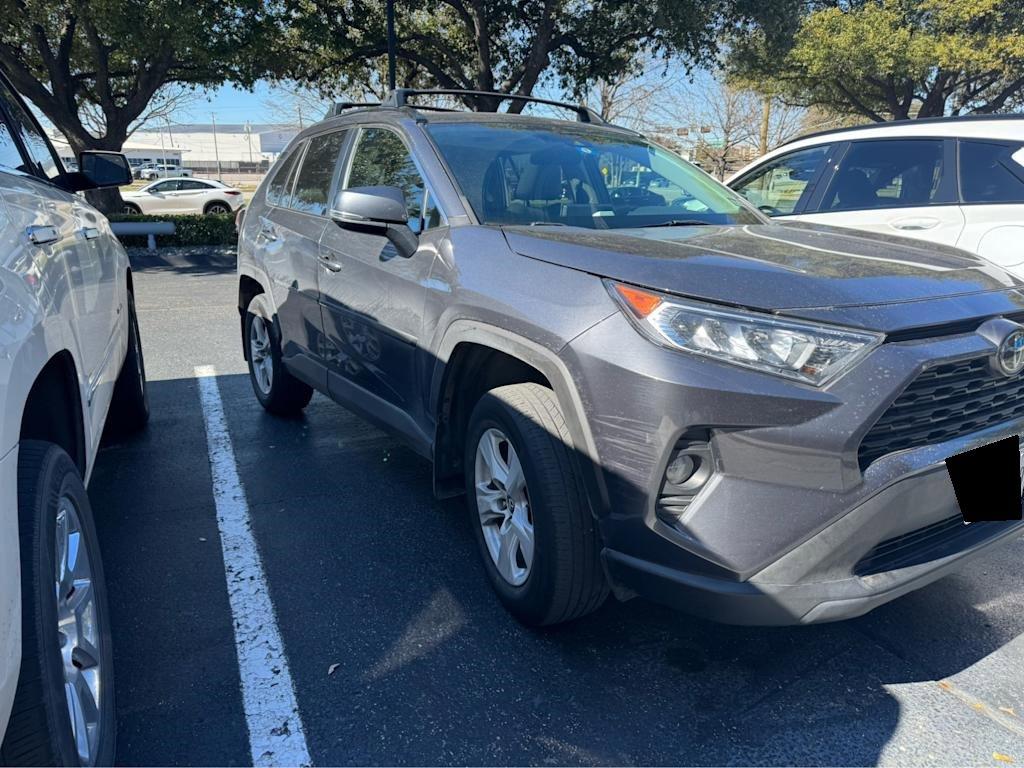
[0,70,148,765]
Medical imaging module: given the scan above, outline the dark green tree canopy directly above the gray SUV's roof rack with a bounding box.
[284,0,790,112]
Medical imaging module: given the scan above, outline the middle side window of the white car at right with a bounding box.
[819,139,954,212]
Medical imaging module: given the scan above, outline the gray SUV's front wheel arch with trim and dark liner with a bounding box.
[429,321,608,514]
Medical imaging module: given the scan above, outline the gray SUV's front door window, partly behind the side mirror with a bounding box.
[345,128,440,232]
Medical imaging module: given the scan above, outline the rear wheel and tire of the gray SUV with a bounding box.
[244,294,313,416]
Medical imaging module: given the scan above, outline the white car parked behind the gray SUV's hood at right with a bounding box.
[728,115,1024,276]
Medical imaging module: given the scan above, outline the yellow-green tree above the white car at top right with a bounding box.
[730,0,1024,121]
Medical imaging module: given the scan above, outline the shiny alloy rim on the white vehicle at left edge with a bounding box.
[54,496,108,765]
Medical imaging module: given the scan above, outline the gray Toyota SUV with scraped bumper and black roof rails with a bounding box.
[239,90,1024,625]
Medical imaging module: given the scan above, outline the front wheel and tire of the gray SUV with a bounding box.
[465,384,608,627]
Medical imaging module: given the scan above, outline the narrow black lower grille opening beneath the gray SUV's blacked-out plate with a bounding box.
[853,515,1022,577]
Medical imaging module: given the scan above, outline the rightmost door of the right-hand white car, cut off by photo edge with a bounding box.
[956,139,1024,276]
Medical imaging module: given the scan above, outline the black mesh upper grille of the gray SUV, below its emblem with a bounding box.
[857,357,1024,470]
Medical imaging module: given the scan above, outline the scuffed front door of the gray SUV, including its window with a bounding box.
[319,127,443,432]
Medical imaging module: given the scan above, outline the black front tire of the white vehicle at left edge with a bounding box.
[0,440,116,766]
